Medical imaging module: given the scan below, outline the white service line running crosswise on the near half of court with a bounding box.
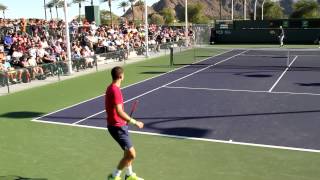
[164,86,320,96]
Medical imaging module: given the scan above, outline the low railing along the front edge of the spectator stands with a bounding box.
[0,40,188,93]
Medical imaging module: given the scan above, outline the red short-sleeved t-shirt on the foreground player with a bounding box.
[105,84,127,127]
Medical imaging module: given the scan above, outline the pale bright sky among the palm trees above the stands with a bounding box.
[0,0,158,20]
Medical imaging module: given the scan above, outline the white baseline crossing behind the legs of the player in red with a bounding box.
[34,120,320,153]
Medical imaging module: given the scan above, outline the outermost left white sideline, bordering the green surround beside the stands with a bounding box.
[31,49,233,121]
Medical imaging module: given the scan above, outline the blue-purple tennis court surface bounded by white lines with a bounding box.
[33,49,320,152]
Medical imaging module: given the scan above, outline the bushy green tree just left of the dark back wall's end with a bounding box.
[188,3,209,24]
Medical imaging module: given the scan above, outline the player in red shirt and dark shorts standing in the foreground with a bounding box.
[105,67,144,180]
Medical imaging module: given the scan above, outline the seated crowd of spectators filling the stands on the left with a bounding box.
[0,19,192,83]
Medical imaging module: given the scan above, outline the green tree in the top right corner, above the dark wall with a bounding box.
[291,0,319,18]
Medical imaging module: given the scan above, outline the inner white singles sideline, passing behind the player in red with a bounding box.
[72,51,246,124]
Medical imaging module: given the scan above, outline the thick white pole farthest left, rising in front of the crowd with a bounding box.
[59,0,72,75]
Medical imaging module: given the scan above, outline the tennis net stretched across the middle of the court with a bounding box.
[190,47,320,70]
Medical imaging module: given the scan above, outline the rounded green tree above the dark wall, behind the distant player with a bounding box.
[263,0,284,19]
